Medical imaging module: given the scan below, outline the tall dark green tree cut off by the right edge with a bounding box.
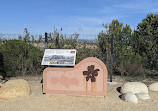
[132,14,158,70]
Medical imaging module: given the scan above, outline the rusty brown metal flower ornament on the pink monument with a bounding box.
[83,65,99,82]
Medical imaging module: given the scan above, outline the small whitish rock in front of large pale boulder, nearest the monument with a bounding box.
[122,92,138,103]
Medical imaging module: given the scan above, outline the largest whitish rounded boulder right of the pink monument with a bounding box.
[121,82,148,94]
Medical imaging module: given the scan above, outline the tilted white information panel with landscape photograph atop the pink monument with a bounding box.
[41,49,76,66]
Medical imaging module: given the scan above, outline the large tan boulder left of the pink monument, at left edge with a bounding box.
[0,79,30,99]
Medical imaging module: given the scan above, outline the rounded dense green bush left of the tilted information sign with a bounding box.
[0,40,43,77]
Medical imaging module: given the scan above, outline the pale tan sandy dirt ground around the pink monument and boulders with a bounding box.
[0,76,158,111]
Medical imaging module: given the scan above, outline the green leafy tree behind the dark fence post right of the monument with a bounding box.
[97,20,142,76]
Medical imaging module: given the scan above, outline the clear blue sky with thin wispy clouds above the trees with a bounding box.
[0,0,158,35]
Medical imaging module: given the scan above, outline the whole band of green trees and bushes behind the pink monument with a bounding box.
[0,14,158,78]
